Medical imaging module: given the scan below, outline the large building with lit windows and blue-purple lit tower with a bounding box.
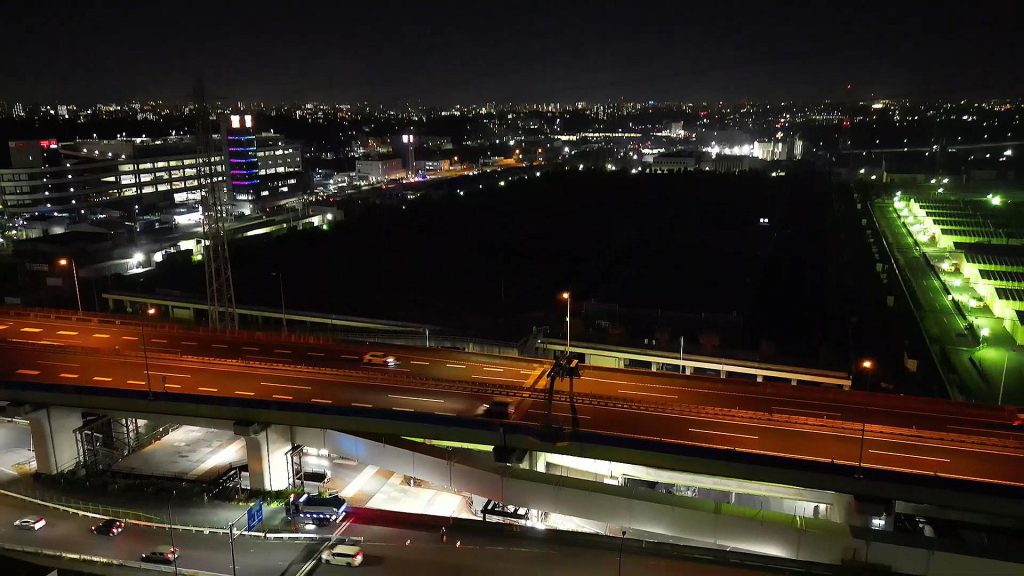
[0,129,304,216]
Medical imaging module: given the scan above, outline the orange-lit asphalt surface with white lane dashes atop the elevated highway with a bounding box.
[0,307,1024,486]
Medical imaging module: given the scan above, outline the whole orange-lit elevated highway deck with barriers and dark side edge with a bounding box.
[0,308,1024,507]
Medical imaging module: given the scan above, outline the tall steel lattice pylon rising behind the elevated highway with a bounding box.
[195,80,238,329]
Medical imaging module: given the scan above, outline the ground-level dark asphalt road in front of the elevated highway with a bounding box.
[0,497,767,576]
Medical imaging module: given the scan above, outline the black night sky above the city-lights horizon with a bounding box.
[0,0,1024,105]
